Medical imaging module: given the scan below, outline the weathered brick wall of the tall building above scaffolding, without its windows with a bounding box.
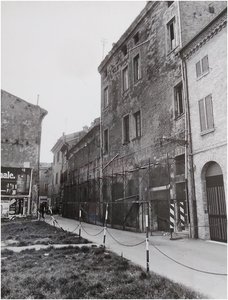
[99,1,224,232]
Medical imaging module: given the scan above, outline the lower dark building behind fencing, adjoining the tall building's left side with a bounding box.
[63,118,102,223]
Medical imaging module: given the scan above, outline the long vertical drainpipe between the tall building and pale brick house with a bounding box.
[181,57,198,238]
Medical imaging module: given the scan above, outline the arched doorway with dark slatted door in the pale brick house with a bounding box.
[205,162,227,242]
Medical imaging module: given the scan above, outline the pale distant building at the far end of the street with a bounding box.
[51,128,86,213]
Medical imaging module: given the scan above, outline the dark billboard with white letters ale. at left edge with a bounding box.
[1,167,32,197]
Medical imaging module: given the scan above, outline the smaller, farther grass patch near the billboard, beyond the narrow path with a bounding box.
[1,220,88,246]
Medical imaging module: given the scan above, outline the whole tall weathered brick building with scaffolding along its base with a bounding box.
[96,1,226,237]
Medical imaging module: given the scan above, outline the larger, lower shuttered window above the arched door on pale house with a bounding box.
[199,95,214,132]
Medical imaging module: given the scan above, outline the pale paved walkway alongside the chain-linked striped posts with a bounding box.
[47,216,227,299]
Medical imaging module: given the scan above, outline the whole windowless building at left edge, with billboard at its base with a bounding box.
[1,90,47,214]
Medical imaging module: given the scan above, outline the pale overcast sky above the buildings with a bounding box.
[1,1,146,162]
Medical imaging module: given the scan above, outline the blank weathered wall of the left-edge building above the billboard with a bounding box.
[1,91,47,212]
